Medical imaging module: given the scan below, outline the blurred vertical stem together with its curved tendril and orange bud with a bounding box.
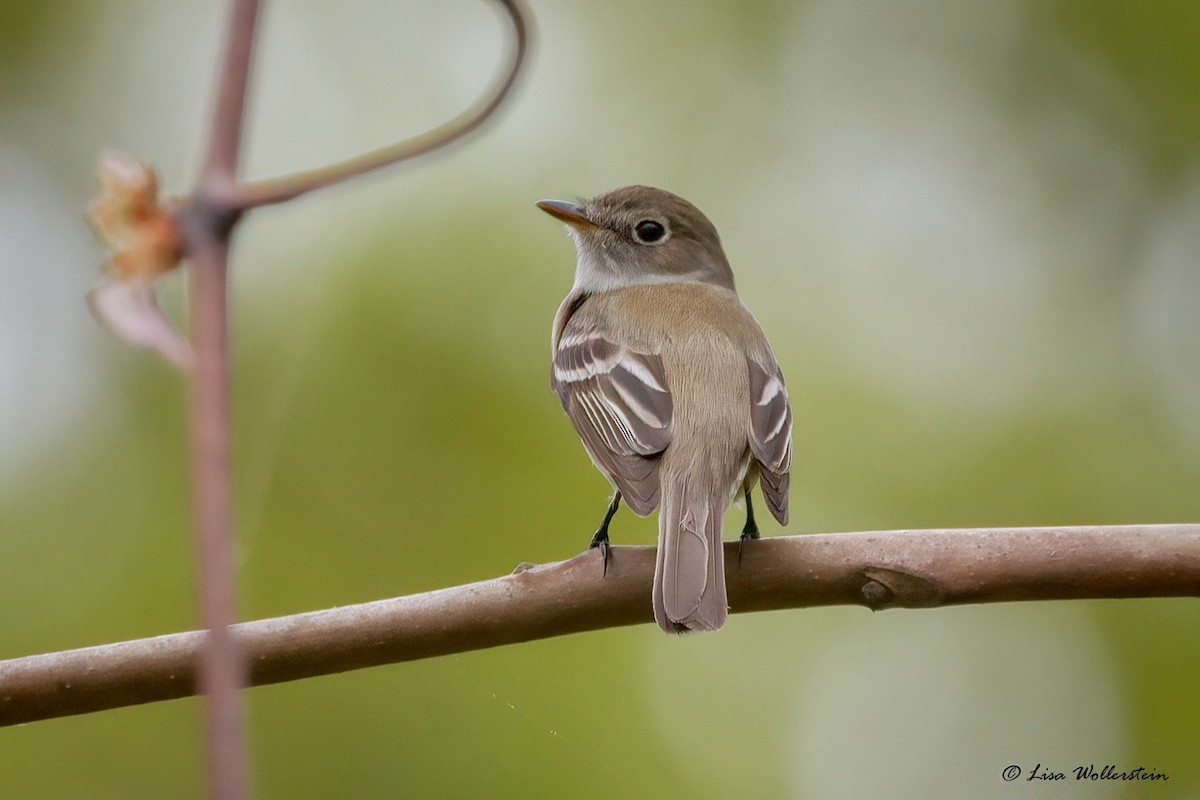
[87,0,529,800]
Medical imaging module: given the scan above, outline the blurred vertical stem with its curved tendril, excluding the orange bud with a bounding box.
[156,0,528,800]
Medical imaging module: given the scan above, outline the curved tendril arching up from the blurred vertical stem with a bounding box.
[230,0,529,210]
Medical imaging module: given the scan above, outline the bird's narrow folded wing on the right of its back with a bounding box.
[746,359,792,525]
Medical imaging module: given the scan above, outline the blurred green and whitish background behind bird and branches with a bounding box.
[0,0,1200,799]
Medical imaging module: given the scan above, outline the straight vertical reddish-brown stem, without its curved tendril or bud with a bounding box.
[181,0,259,800]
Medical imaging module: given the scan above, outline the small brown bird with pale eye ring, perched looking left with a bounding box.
[538,186,792,633]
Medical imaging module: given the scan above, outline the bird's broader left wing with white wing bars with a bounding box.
[551,326,672,515]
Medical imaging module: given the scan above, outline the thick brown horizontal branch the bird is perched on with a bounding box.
[0,524,1200,726]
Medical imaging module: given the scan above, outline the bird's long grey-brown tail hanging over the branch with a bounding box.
[654,470,730,633]
